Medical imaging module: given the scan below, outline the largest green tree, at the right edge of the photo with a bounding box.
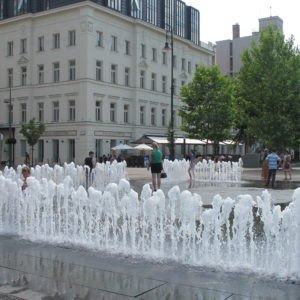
[236,26,300,149]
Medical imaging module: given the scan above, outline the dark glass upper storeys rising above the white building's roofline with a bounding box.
[0,0,200,45]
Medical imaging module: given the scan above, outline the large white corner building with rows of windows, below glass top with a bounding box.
[0,1,214,164]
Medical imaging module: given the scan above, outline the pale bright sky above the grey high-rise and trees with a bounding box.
[184,0,300,45]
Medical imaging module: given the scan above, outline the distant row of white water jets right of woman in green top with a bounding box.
[163,159,242,182]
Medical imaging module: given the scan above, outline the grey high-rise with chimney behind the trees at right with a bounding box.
[216,16,283,76]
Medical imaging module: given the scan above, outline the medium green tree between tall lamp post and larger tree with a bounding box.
[179,65,234,154]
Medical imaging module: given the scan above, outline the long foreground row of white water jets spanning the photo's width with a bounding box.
[0,171,300,280]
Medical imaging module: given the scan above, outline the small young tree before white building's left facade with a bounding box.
[20,118,46,164]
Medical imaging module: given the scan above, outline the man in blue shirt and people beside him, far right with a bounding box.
[261,149,292,187]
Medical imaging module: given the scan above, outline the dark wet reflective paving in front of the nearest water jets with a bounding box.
[0,237,300,300]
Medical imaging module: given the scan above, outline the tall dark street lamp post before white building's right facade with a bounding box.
[164,26,175,160]
